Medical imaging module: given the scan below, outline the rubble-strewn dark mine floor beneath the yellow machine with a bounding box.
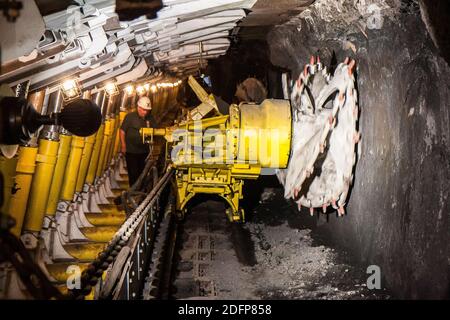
[171,187,391,299]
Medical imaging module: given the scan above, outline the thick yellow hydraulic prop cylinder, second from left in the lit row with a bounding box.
[23,139,59,232]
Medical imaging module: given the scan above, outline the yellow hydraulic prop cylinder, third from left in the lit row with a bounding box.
[45,134,72,216]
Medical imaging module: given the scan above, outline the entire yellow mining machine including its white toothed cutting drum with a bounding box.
[141,57,359,222]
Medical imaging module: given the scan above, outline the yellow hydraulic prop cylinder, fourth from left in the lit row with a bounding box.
[60,136,84,201]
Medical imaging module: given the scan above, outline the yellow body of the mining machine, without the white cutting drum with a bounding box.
[141,76,292,222]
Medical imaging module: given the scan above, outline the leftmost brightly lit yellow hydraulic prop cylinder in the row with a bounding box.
[8,146,38,237]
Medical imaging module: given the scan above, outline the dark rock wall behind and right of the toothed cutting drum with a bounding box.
[208,1,450,299]
